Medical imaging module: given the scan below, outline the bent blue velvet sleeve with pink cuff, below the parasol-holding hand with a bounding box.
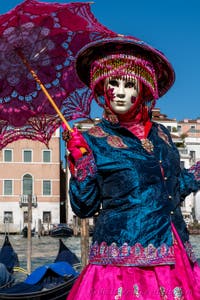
[69,152,100,218]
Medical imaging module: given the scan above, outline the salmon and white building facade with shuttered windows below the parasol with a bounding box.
[0,130,61,233]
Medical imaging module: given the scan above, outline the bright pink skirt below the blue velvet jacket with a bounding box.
[67,228,200,300]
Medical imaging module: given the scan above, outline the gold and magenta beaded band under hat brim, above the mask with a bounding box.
[90,53,159,99]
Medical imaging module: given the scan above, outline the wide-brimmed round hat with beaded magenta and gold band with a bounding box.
[76,35,175,105]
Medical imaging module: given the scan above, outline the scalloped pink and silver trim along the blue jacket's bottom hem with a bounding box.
[89,242,175,266]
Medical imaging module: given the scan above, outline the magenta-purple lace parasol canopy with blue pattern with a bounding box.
[0,0,115,149]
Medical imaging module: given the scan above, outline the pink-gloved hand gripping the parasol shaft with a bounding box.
[62,128,89,161]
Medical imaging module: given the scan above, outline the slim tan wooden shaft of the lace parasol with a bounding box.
[16,49,87,154]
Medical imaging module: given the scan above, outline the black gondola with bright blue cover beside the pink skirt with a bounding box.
[0,239,80,300]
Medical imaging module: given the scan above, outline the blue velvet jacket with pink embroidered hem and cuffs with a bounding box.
[70,119,199,266]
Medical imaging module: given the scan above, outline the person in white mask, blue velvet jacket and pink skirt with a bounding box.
[63,36,200,300]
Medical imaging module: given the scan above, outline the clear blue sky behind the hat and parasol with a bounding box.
[0,0,200,120]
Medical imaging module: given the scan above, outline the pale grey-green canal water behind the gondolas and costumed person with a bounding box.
[0,234,200,271]
